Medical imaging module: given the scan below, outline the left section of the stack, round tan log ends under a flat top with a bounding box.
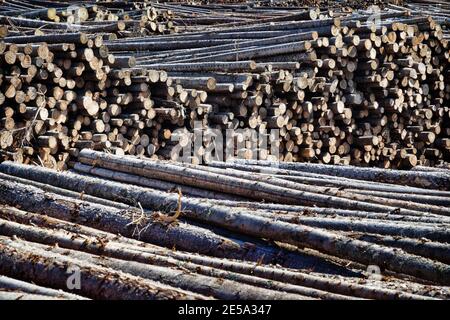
[0,33,184,169]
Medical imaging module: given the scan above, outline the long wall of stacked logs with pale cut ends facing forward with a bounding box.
[0,2,450,168]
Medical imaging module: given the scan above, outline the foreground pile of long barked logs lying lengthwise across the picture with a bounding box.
[0,149,450,299]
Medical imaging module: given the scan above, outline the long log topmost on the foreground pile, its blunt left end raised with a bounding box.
[75,149,434,212]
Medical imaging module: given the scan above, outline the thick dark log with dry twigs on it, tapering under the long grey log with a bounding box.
[0,176,342,268]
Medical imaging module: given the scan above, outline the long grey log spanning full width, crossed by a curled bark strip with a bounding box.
[0,162,450,284]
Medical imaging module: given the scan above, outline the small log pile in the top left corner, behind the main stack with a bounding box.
[0,1,176,39]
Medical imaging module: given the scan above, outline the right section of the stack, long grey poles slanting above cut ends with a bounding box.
[115,11,450,168]
